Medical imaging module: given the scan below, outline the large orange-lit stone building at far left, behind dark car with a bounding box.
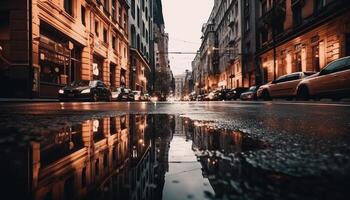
[0,0,129,98]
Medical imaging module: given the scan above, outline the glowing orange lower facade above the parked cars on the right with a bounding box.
[260,11,350,83]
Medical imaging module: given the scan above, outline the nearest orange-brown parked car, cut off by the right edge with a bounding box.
[296,56,350,100]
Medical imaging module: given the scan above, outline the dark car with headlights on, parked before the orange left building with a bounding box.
[58,80,112,101]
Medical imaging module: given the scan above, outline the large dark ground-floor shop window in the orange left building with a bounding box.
[39,22,82,98]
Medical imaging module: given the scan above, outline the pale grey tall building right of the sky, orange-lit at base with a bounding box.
[214,0,243,88]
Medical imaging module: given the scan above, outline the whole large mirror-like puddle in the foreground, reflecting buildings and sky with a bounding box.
[0,115,348,200]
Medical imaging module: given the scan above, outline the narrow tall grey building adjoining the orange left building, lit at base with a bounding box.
[129,0,152,92]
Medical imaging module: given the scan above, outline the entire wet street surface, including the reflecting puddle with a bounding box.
[0,102,350,200]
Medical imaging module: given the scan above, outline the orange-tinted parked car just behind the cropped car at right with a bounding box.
[257,72,316,100]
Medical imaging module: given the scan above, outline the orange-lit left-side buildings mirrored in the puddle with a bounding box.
[0,115,178,200]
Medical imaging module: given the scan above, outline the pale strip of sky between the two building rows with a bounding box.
[162,0,214,75]
